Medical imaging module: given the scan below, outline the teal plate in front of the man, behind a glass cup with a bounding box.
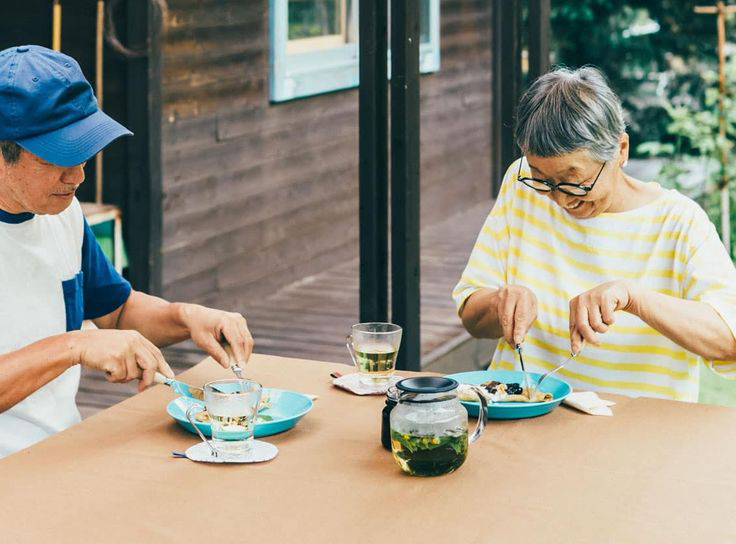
[166,388,313,438]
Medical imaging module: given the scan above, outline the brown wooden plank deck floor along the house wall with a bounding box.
[77,200,491,417]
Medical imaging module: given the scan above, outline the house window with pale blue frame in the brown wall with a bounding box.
[270,0,440,102]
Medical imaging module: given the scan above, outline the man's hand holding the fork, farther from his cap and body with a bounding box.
[182,304,253,368]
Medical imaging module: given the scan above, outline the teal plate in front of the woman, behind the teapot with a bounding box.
[447,370,572,419]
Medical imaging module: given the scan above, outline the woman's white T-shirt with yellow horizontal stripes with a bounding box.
[453,159,736,401]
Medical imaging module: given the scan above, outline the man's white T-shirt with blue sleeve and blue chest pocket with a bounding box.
[0,199,131,457]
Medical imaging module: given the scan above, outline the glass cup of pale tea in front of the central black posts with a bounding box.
[345,323,401,385]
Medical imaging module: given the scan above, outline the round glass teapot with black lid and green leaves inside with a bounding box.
[391,376,487,476]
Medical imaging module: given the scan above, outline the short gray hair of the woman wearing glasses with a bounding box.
[515,66,626,161]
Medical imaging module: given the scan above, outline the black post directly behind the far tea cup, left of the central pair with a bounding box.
[358,0,388,322]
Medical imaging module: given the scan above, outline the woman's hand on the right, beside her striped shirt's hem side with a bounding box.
[570,280,635,353]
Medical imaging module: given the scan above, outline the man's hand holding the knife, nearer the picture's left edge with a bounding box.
[70,329,174,391]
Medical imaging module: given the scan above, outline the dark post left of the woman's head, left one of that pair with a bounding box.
[491,0,521,196]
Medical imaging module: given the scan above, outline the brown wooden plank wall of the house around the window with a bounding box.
[161,0,491,311]
